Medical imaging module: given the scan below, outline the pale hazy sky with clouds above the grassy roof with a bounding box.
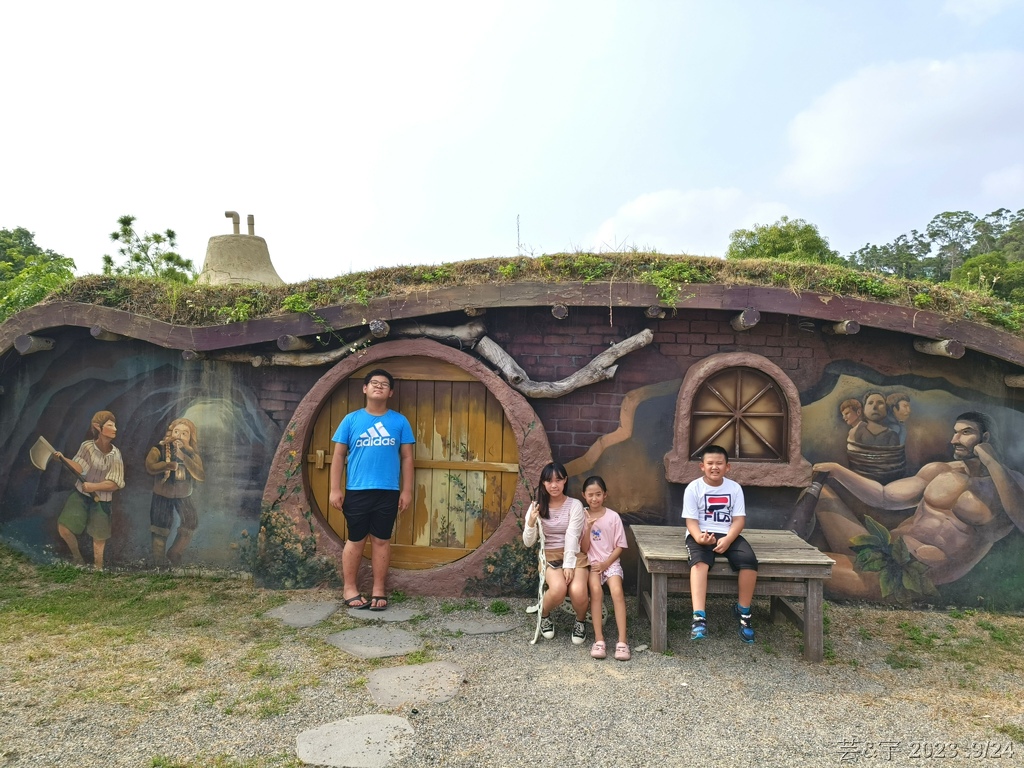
[0,0,1024,283]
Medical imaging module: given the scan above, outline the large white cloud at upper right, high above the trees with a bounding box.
[780,51,1024,195]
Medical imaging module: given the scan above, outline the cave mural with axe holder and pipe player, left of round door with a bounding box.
[0,338,282,569]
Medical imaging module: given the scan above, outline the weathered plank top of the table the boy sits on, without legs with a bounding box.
[631,525,835,566]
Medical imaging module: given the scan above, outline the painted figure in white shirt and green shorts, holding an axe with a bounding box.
[55,411,125,570]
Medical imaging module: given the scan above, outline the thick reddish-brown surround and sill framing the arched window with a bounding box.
[665,352,811,487]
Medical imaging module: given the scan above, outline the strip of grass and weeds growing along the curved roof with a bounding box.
[48,250,1024,341]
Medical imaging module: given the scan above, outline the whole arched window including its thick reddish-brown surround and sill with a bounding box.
[665,352,811,487]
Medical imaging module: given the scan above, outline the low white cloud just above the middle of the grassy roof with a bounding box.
[586,187,790,256]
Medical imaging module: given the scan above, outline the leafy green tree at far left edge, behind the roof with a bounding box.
[0,226,75,322]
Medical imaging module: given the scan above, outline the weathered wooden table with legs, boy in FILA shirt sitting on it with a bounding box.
[632,525,834,662]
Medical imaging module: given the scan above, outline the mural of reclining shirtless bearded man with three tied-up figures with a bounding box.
[786,376,1024,606]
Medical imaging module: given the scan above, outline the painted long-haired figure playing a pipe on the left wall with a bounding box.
[145,419,206,567]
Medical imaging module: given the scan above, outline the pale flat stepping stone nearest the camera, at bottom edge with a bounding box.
[295,715,416,768]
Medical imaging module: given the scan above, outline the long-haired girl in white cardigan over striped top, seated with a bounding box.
[522,462,589,645]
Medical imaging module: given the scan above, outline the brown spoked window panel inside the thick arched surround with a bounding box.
[690,366,788,462]
